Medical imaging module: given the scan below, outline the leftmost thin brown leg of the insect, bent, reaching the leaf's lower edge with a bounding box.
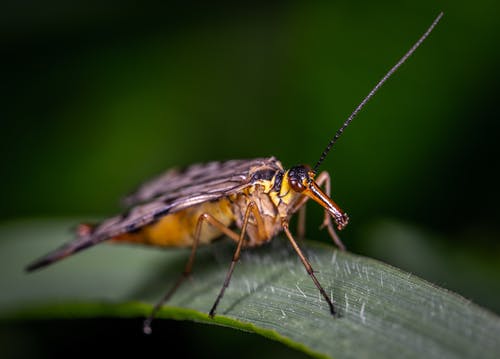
[143,213,240,334]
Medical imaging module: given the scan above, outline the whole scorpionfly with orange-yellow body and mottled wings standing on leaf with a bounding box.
[27,13,443,333]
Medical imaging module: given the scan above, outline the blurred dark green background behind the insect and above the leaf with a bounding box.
[0,0,500,353]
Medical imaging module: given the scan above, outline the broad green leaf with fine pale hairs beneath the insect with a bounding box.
[0,221,500,358]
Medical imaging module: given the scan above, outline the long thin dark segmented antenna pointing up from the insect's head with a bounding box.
[313,12,443,173]
